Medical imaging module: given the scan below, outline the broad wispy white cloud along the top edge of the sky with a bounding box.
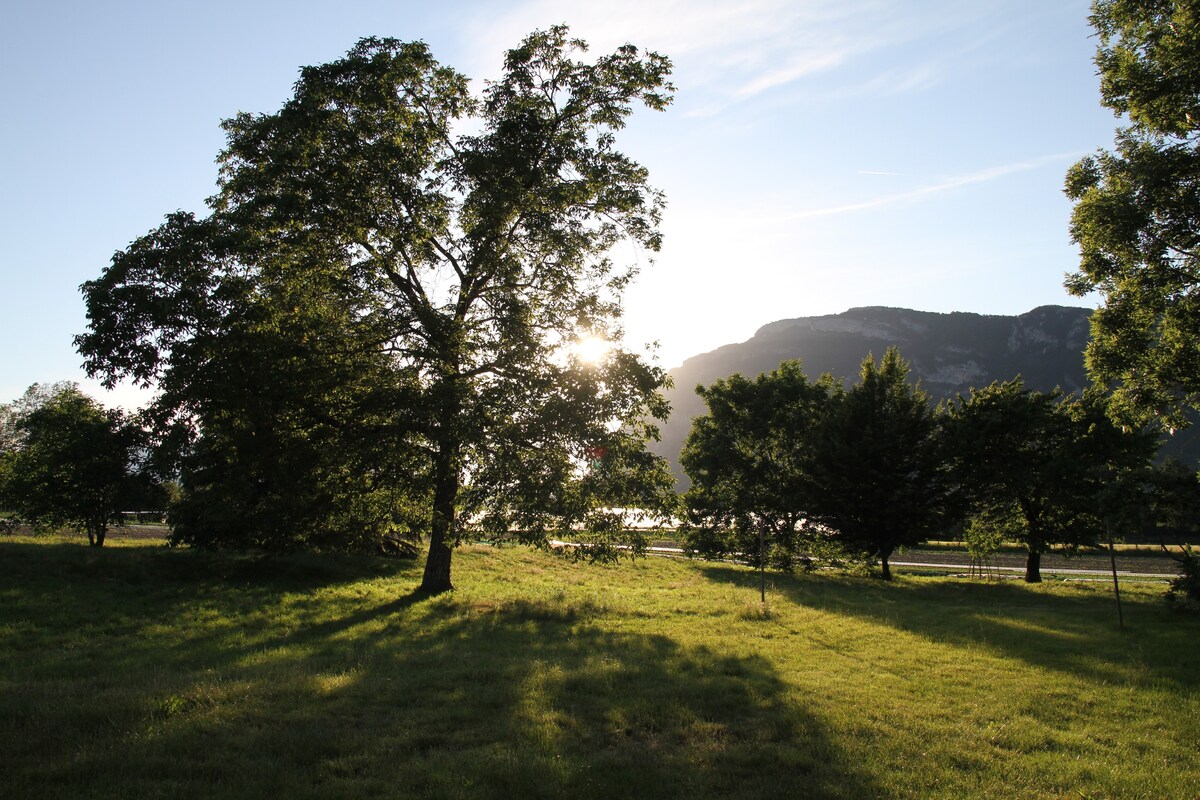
[464,0,1003,115]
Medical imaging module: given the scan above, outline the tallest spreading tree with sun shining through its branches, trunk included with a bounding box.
[78,28,672,593]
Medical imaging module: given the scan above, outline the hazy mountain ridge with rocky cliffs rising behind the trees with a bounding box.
[654,306,1091,479]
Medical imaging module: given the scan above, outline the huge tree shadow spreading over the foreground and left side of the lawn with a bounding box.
[0,544,883,800]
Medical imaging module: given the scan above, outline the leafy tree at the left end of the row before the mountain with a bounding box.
[680,361,841,570]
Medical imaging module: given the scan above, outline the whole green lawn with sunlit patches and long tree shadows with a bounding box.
[0,537,1200,800]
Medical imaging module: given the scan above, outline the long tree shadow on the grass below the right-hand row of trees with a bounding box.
[703,565,1200,691]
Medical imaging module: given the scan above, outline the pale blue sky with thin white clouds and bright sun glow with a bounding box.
[0,0,1120,407]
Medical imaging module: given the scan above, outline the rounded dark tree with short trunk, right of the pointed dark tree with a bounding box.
[949,378,1157,583]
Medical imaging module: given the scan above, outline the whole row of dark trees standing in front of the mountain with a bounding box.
[683,348,1198,582]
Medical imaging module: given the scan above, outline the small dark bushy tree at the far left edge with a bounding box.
[0,385,145,547]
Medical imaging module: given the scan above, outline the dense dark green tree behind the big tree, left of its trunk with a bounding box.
[164,260,428,555]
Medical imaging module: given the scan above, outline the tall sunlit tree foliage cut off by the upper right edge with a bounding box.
[1066,0,1200,426]
